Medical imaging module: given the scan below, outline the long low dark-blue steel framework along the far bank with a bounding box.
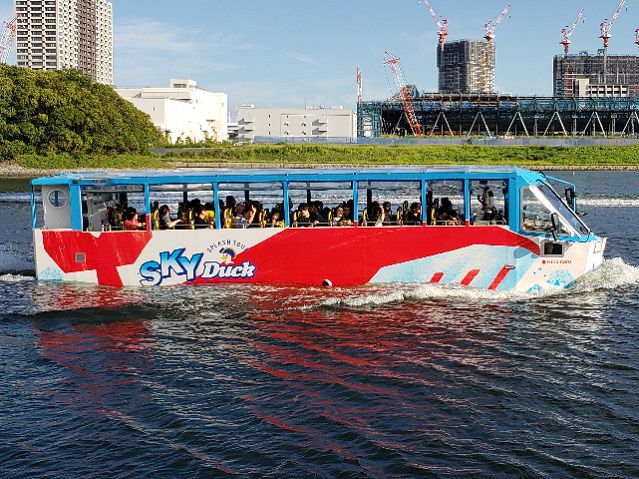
[358,94,639,138]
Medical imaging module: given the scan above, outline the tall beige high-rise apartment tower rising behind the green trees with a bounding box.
[13,0,113,84]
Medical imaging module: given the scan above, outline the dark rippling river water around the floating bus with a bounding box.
[0,172,639,478]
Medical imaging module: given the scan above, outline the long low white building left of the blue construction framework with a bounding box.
[237,105,357,142]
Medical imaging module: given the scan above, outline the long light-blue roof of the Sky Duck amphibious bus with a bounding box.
[32,166,543,186]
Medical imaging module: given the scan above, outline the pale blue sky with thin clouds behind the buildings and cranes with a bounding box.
[0,0,639,113]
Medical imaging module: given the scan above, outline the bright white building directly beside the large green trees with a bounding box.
[115,80,228,143]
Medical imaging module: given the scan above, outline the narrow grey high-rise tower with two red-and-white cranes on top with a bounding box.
[437,40,495,94]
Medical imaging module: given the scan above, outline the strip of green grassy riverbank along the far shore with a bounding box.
[0,145,639,176]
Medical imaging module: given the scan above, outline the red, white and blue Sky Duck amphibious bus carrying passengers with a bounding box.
[31,167,606,292]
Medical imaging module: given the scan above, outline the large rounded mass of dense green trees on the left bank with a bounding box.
[0,65,162,160]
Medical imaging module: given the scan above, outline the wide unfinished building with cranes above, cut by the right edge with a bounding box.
[553,50,639,98]
